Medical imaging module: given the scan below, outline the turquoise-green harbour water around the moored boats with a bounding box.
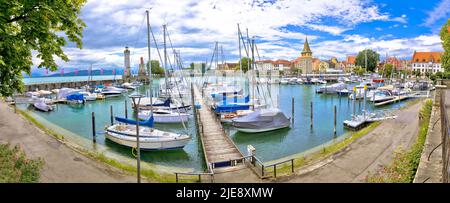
[21,78,405,171]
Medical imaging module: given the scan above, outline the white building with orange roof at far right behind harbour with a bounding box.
[411,51,444,74]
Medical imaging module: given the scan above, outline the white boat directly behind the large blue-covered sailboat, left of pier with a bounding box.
[138,109,189,123]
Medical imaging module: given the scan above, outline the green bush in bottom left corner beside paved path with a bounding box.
[0,144,44,183]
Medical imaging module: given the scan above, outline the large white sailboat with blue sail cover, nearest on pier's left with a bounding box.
[105,117,191,150]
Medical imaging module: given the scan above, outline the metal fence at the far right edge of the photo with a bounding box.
[440,90,450,183]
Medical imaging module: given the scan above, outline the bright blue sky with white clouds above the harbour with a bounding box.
[34,0,450,73]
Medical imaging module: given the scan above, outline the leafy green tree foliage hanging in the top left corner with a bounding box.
[0,0,86,96]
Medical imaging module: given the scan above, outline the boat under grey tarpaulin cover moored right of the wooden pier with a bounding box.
[232,108,291,133]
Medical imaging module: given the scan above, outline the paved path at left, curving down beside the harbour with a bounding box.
[0,101,136,183]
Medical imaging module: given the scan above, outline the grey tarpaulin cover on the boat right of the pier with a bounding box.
[233,108,290,129]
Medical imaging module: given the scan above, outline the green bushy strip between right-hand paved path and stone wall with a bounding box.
[365,100,433,183]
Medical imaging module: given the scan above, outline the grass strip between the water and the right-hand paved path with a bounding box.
[265,122,381,177]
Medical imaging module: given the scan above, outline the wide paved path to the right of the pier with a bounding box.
[277,102,423,183]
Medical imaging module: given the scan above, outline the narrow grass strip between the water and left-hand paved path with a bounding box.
[17,109,197,182]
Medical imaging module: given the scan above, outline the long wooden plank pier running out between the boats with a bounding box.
[194,85,244,171]
